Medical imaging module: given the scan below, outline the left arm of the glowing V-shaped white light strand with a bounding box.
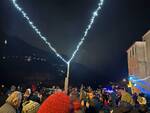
[11,0,67,63]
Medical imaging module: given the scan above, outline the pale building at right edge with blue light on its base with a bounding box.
[127,31,150,94]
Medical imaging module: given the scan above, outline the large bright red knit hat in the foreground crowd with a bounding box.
[38,92,70,113]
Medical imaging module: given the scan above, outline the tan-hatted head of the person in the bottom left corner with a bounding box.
[6,91,22,108]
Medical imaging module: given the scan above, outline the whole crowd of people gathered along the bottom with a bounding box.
[0,85,150,113]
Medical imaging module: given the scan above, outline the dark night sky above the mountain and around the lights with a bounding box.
[0,0,150,81]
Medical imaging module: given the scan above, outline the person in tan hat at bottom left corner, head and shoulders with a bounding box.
[0,91,22,113]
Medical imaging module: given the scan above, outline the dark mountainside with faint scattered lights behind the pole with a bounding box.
[0,33,98,86]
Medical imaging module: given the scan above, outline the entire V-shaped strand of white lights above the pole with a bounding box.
[11,0,104,65]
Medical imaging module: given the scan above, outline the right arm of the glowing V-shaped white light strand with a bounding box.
[68,0,104,63]
